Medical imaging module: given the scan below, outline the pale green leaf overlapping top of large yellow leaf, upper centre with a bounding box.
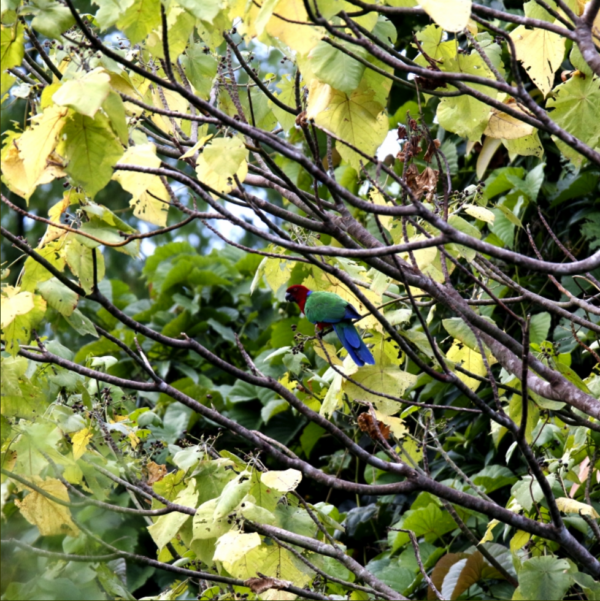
[308,40,365,95]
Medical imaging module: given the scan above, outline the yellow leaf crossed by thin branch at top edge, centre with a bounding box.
[265,0,322,54]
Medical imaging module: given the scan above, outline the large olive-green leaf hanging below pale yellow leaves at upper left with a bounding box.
[60,113,123,198]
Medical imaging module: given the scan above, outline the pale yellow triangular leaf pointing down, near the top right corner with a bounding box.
[510,25,566,96]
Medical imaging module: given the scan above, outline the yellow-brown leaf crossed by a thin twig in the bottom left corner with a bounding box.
[15,476,79,536]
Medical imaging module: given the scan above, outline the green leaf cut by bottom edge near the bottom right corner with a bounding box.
[519,555,573,601]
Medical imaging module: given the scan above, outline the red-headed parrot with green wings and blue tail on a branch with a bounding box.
[285,285,375,367]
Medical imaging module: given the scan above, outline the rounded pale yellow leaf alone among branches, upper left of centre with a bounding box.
[196,138,248,193]
